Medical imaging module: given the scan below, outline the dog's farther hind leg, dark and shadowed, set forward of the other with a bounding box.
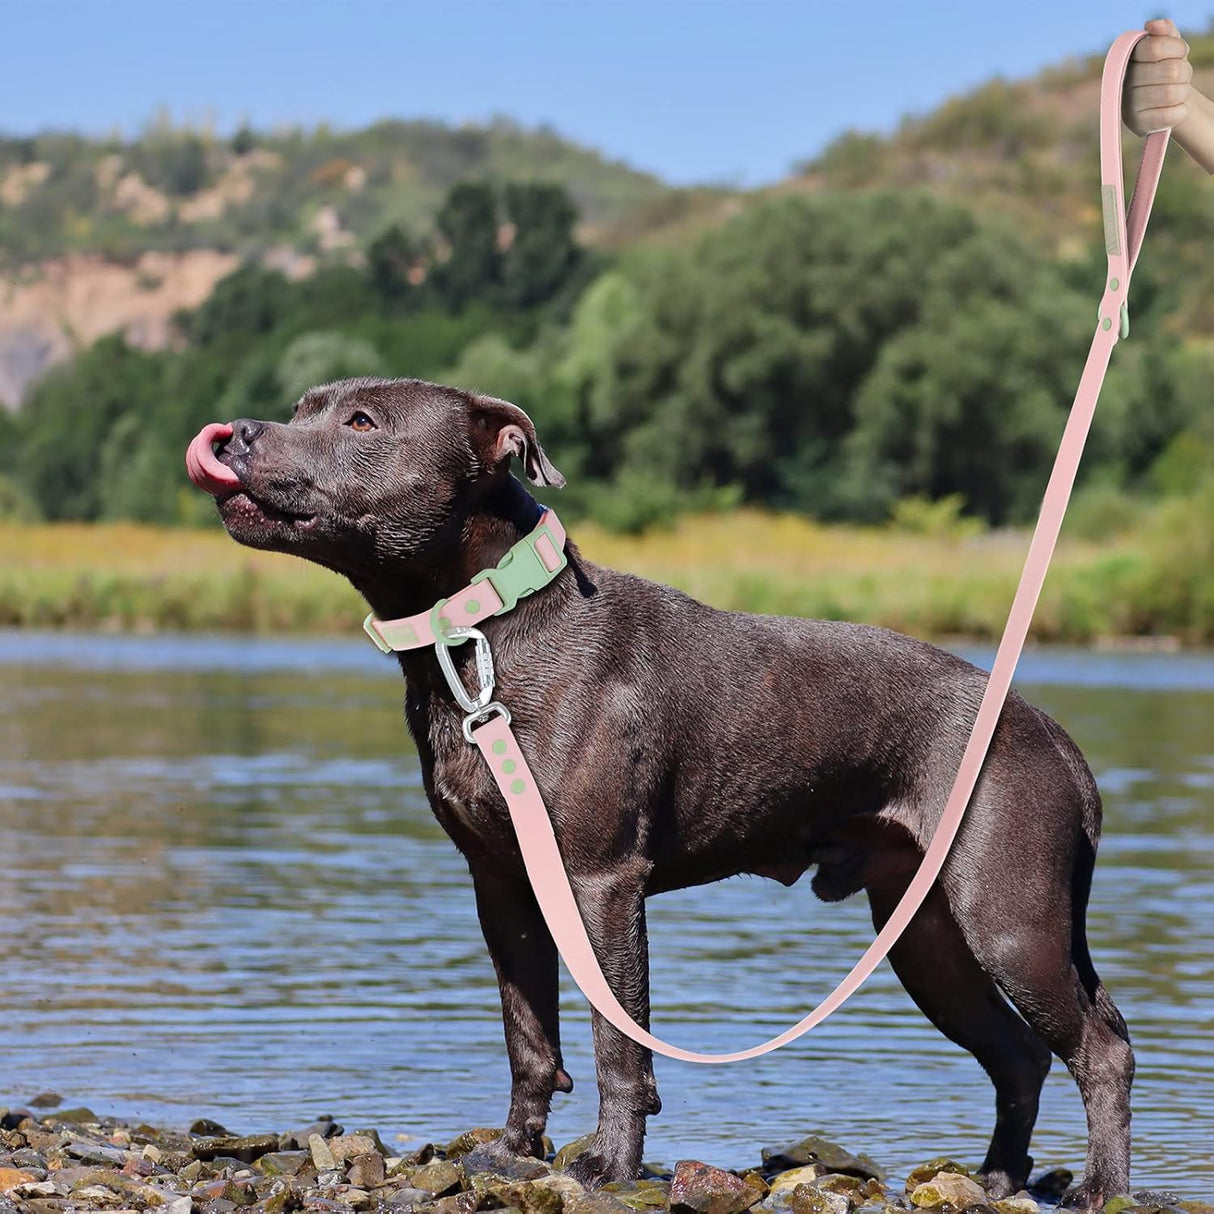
[867,874,1050,1197]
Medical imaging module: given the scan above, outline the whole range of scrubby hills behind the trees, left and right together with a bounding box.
[7,25,1214,407]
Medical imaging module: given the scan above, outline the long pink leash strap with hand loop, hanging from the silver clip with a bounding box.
[472,30,1168,1062]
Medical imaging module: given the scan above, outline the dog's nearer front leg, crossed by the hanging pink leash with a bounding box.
[569,858,662,1185]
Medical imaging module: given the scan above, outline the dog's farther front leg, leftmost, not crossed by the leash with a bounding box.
[472,870,573,1157]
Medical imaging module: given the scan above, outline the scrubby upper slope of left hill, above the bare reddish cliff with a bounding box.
[0,119,689,266]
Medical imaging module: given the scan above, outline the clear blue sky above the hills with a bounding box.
[7,0,1214,185]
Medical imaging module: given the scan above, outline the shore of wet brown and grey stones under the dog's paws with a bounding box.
[0,1108,1214,1214]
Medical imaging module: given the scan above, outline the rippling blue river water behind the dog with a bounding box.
[0,632,1214,1198]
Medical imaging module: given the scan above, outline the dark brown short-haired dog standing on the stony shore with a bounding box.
[196,379,1134,1207]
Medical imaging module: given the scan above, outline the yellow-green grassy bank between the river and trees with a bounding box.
[0,498,1214,645]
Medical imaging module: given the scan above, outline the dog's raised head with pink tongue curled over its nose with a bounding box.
[186,379,565,575]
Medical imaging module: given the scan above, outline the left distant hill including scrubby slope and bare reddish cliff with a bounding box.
[0,120,694,407]
